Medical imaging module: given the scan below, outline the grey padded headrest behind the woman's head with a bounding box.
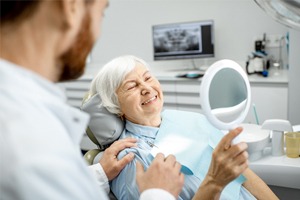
[81,94,125,149]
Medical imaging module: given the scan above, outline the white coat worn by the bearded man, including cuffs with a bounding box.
[0,60,174,200]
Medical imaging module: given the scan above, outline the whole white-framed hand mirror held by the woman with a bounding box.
[200,60,251,143]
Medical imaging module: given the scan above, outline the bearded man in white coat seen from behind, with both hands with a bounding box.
[0,0,183,200]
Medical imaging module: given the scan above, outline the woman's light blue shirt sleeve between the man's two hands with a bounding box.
[111,149,140,200]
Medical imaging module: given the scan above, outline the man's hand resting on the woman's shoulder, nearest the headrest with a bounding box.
[99,138,137,180]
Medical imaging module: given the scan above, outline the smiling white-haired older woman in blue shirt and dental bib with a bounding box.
[90,56,276,199]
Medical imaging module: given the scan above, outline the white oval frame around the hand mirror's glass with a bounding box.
[200,59,251,130]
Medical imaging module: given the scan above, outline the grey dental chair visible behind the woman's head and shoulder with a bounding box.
[81,94,125,200]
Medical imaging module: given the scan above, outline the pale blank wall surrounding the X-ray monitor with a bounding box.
[86,0,288,71]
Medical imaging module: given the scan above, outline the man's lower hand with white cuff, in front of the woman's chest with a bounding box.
[136,153,184,199]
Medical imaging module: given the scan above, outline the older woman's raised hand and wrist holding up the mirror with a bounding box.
[194,127,248,199]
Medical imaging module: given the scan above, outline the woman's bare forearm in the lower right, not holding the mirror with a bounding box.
[243,168,278,200]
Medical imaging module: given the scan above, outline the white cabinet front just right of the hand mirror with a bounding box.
[244,83,288,124]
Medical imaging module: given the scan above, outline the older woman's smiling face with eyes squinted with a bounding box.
[117,63,163,126]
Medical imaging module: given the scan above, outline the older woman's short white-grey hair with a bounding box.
[89,55,149,115]
